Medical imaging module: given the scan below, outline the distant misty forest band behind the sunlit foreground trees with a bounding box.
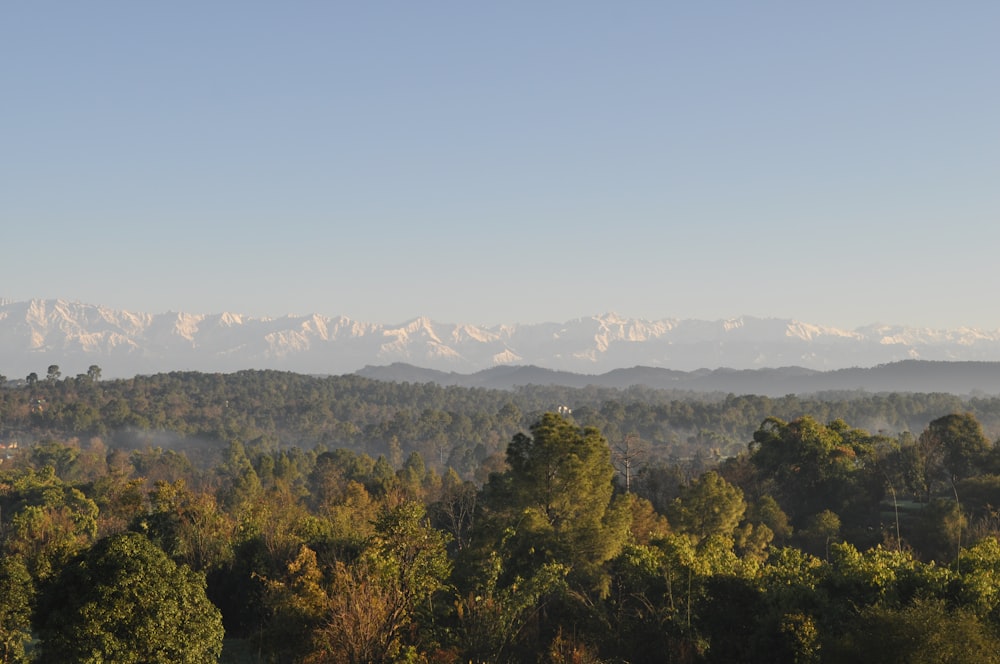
[0,366,1000,479]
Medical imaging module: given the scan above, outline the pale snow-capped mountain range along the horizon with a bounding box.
[0,300,1000,378]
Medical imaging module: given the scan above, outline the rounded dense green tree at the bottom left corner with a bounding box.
[35,533,223,664]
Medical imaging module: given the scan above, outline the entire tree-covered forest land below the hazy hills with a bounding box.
[0,366,1000,663]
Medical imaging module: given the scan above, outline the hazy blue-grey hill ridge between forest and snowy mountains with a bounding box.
[357,360,1000,397]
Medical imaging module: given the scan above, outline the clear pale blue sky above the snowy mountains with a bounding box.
[0,0,1000,329]
